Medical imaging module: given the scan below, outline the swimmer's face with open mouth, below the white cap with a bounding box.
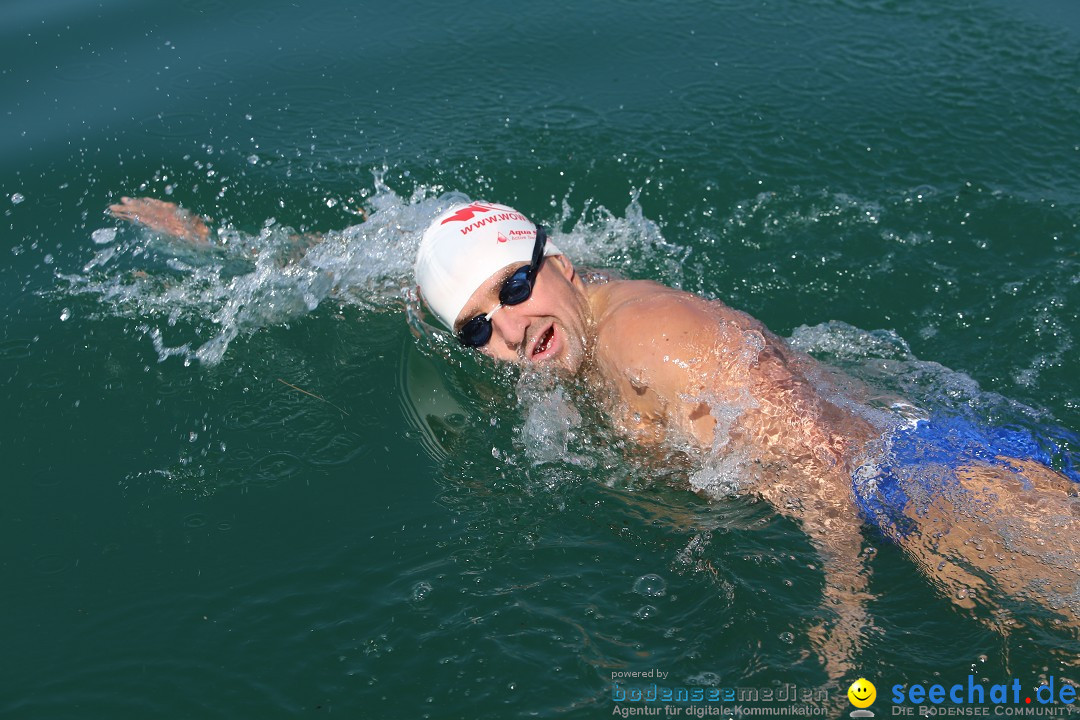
[455,255,592,372]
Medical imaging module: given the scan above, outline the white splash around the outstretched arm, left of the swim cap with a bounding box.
[60,175,463,365]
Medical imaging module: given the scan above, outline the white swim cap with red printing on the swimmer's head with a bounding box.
[414,202,559,330]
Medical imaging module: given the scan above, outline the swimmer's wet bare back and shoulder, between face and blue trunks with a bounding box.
[591,281,846,454]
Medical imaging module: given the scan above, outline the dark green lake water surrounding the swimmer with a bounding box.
[0,0,1080,718]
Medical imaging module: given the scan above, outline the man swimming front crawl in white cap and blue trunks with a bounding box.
[110,199,1080,679]
